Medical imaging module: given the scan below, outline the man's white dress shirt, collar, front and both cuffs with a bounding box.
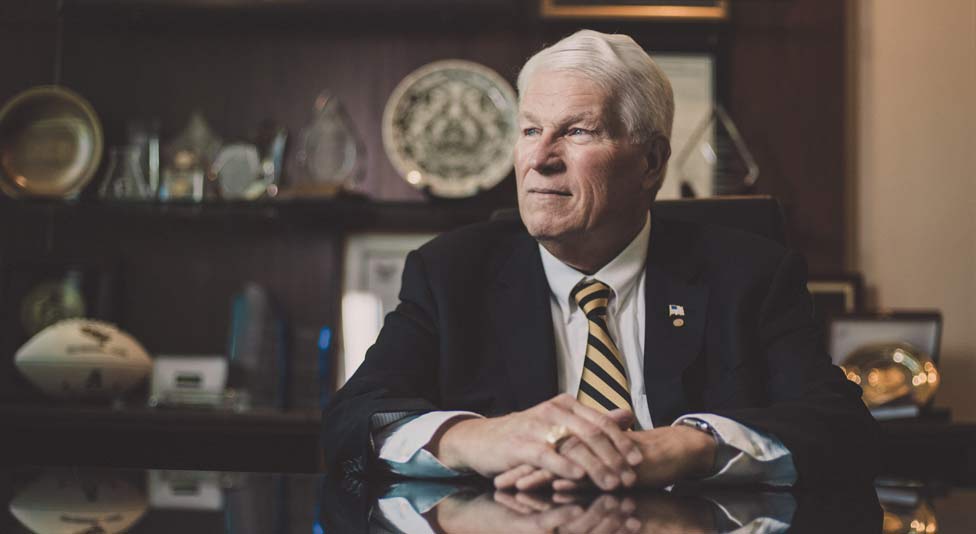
[373,215,796,485]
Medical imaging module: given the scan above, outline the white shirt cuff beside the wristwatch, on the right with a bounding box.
[672,413,796,486]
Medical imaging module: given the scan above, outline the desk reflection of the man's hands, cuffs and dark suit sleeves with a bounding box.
[324,480,882,534]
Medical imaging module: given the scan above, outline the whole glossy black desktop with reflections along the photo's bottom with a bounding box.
[0,468,976,534]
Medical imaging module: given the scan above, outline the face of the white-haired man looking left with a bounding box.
[515,71,657,242]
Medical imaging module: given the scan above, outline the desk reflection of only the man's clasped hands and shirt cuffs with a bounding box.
[370,481,800,534]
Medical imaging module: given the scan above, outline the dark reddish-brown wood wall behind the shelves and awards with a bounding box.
[0,0,845,406]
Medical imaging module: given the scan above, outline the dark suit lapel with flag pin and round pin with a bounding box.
[644,217,708,427]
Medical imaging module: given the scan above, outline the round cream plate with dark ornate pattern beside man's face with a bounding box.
[383,60,518,198]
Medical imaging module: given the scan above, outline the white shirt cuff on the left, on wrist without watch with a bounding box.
[373,411,481,478]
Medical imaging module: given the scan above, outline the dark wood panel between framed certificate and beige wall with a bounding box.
[724,0,847,273]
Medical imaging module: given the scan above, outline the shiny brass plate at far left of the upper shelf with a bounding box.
[0,86,103,198]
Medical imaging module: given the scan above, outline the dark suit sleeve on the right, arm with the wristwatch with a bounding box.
[715,252,880,486]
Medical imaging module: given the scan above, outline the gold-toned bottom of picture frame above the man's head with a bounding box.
[541,0,729,21]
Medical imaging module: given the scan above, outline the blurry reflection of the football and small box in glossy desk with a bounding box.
[0,467,321,534]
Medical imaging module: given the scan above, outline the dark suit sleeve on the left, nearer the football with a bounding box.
[322,251,438,473]
